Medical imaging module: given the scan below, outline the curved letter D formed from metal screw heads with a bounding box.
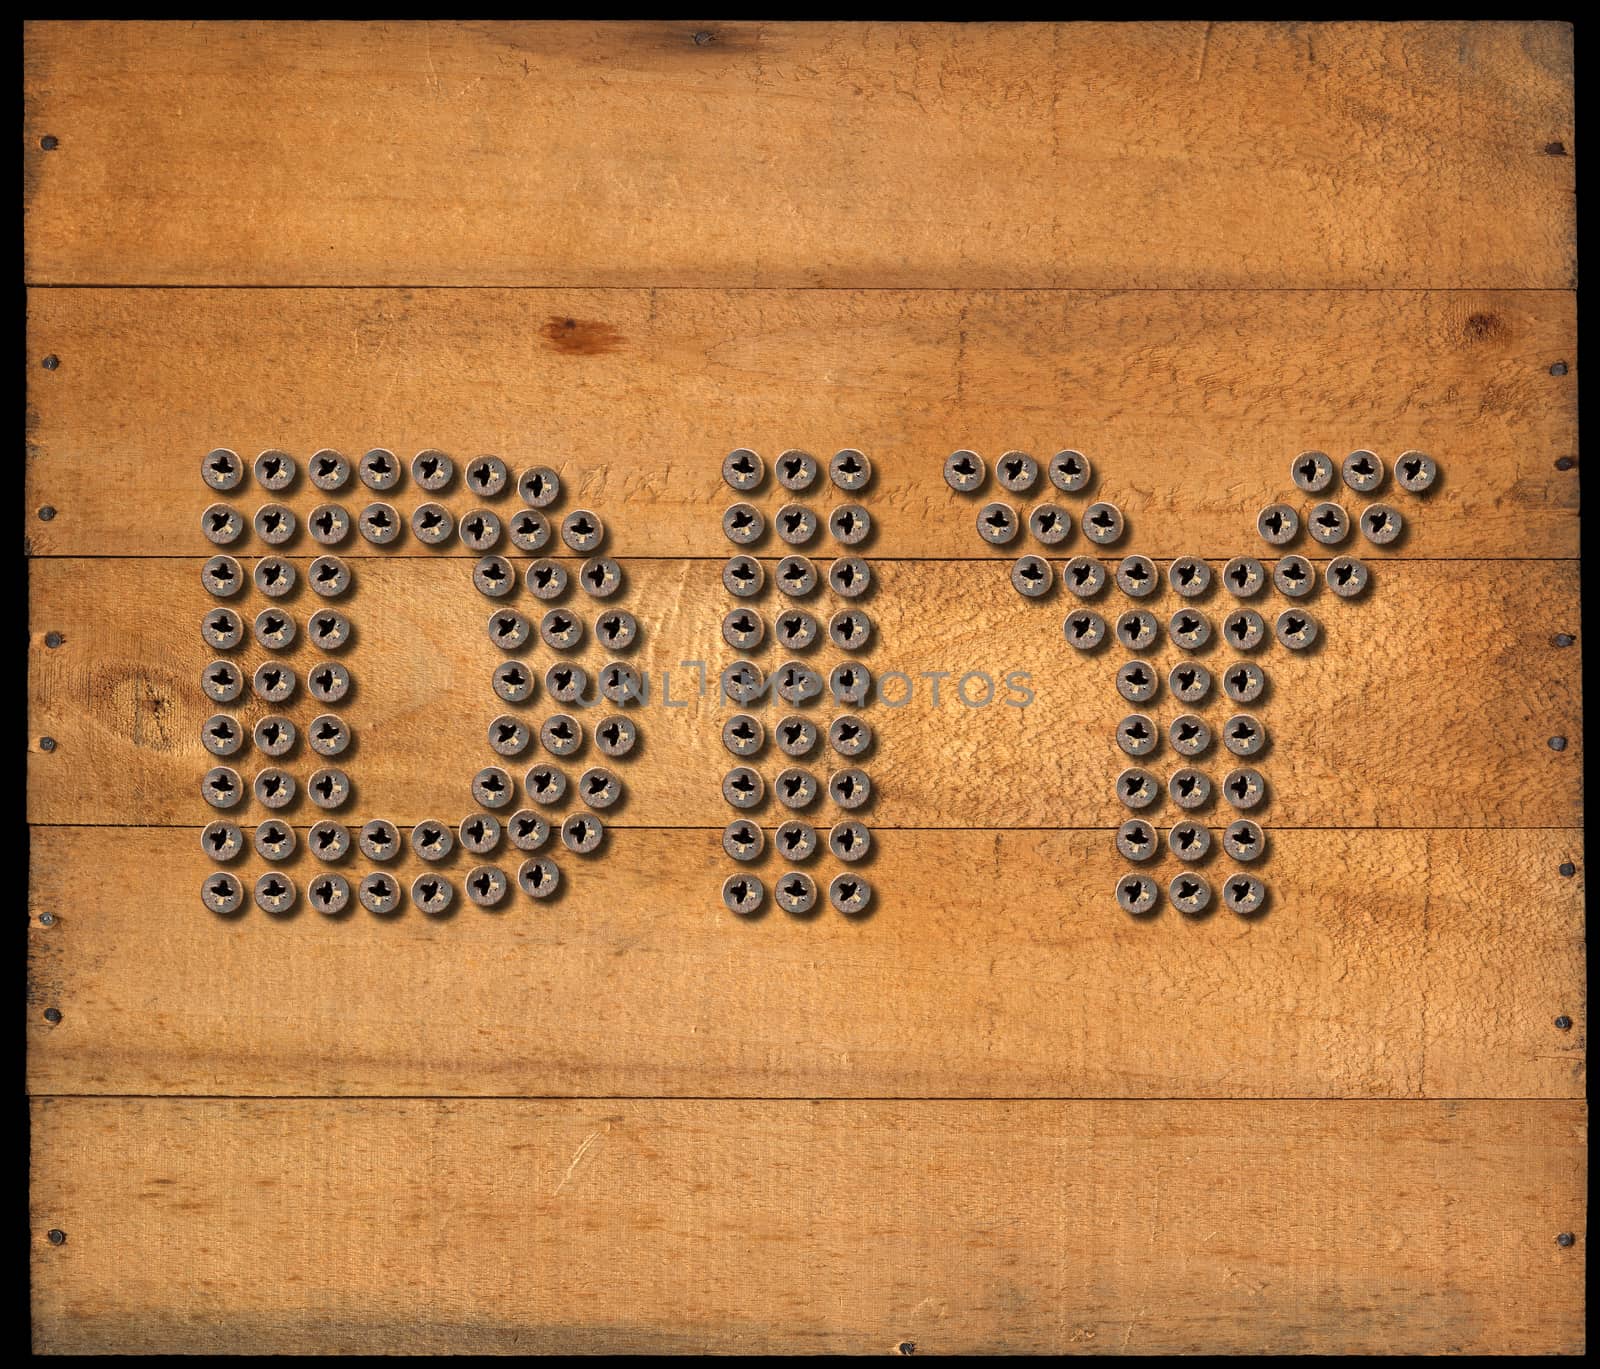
[202,448,642,916]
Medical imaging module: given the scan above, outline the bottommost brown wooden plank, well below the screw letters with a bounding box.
[30,1099,1587,1355]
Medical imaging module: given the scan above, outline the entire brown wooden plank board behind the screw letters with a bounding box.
[22,21,1587,1353]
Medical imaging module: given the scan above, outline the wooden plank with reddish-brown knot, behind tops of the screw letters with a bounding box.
[26,289,1578,558]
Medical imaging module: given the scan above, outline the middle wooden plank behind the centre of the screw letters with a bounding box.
[29,558,1584,828]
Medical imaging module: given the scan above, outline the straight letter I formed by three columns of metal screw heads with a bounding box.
[720,448,874,916]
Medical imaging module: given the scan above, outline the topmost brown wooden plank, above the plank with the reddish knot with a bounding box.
[24,22,1576,288]
